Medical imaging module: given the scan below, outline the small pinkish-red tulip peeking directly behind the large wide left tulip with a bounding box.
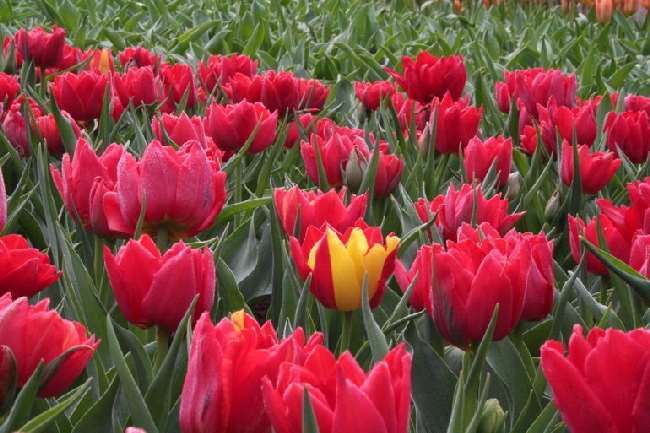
[151,112,210,149]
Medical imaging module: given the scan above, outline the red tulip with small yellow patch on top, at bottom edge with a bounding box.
[180,311,322,433]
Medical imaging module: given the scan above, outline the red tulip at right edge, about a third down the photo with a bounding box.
[605,111,650,164]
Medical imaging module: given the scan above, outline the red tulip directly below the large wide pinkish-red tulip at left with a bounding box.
[104,234,216,333]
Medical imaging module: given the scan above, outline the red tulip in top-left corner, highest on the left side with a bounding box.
[14,26,65,68]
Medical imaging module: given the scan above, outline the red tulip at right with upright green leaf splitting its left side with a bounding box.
[560,141,621,194]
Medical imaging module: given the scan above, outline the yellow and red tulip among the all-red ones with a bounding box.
[290,221,399,311]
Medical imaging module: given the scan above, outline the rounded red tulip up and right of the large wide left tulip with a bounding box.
[204,101,278,154]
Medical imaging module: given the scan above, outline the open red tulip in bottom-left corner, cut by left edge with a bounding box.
[0,293,99,398]
